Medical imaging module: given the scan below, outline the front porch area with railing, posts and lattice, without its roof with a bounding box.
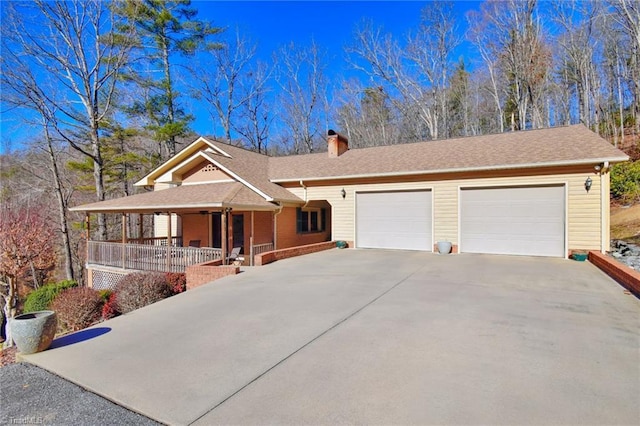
[86,208,275,289]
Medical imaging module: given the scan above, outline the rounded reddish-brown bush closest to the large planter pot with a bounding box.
[51,287,104,332]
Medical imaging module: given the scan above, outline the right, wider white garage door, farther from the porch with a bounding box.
[460,186,565,257]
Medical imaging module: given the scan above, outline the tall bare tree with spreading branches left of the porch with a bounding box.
[3,0,130,239]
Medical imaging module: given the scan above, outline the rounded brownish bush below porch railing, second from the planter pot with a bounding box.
[115,272,173,314]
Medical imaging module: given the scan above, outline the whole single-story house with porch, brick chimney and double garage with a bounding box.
[72,125,628,288]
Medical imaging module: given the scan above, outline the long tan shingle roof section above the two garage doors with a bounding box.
[269,124,629,182]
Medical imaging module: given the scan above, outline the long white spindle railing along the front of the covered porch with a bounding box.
[87,241,222,272]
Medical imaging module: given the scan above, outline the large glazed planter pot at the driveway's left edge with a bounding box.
[11,311,58,355]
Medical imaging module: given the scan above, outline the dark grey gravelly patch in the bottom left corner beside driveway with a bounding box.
[0,362,160,425]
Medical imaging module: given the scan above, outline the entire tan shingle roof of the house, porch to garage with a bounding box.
[72,125,628,212]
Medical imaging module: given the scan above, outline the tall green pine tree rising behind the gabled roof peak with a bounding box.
[113,0,222,158]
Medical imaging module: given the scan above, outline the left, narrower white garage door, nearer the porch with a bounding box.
[356,191,433,251]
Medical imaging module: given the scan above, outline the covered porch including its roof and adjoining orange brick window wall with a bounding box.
[72,183,331,288]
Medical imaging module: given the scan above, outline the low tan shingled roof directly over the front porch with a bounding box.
[69,182,278,213]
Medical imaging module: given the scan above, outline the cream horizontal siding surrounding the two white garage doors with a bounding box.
[300,168,608,256]
